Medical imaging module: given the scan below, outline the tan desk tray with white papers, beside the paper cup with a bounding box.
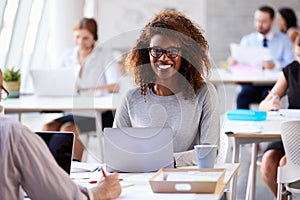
[149,168,225,193]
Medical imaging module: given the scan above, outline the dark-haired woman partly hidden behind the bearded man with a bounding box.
[278,8,300,43]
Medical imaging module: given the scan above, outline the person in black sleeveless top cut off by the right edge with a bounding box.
[259,34,300,196]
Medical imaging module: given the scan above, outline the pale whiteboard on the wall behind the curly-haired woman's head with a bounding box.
[97,0,206,48]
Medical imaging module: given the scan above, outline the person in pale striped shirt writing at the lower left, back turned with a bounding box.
[0,70,121,200]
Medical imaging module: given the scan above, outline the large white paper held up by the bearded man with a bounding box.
[230,43,272,66]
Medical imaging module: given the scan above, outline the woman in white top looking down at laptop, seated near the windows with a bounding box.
[42,18,119,161]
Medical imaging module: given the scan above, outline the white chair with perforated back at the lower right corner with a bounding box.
[277,120,300,200]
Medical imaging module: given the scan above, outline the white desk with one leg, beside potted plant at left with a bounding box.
[4,94,120,162]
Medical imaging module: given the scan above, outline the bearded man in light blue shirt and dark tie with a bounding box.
[228,6,294,109]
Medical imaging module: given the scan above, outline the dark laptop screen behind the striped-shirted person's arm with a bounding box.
[35,131,74,174]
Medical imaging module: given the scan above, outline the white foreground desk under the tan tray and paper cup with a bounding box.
[71,163,240,200]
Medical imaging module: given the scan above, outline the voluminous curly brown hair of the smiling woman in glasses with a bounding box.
[125,10,211,99]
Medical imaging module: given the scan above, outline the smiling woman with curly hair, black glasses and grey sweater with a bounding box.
[114,10,220,166]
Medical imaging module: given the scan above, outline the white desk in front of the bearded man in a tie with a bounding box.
[209,68,281,84]
